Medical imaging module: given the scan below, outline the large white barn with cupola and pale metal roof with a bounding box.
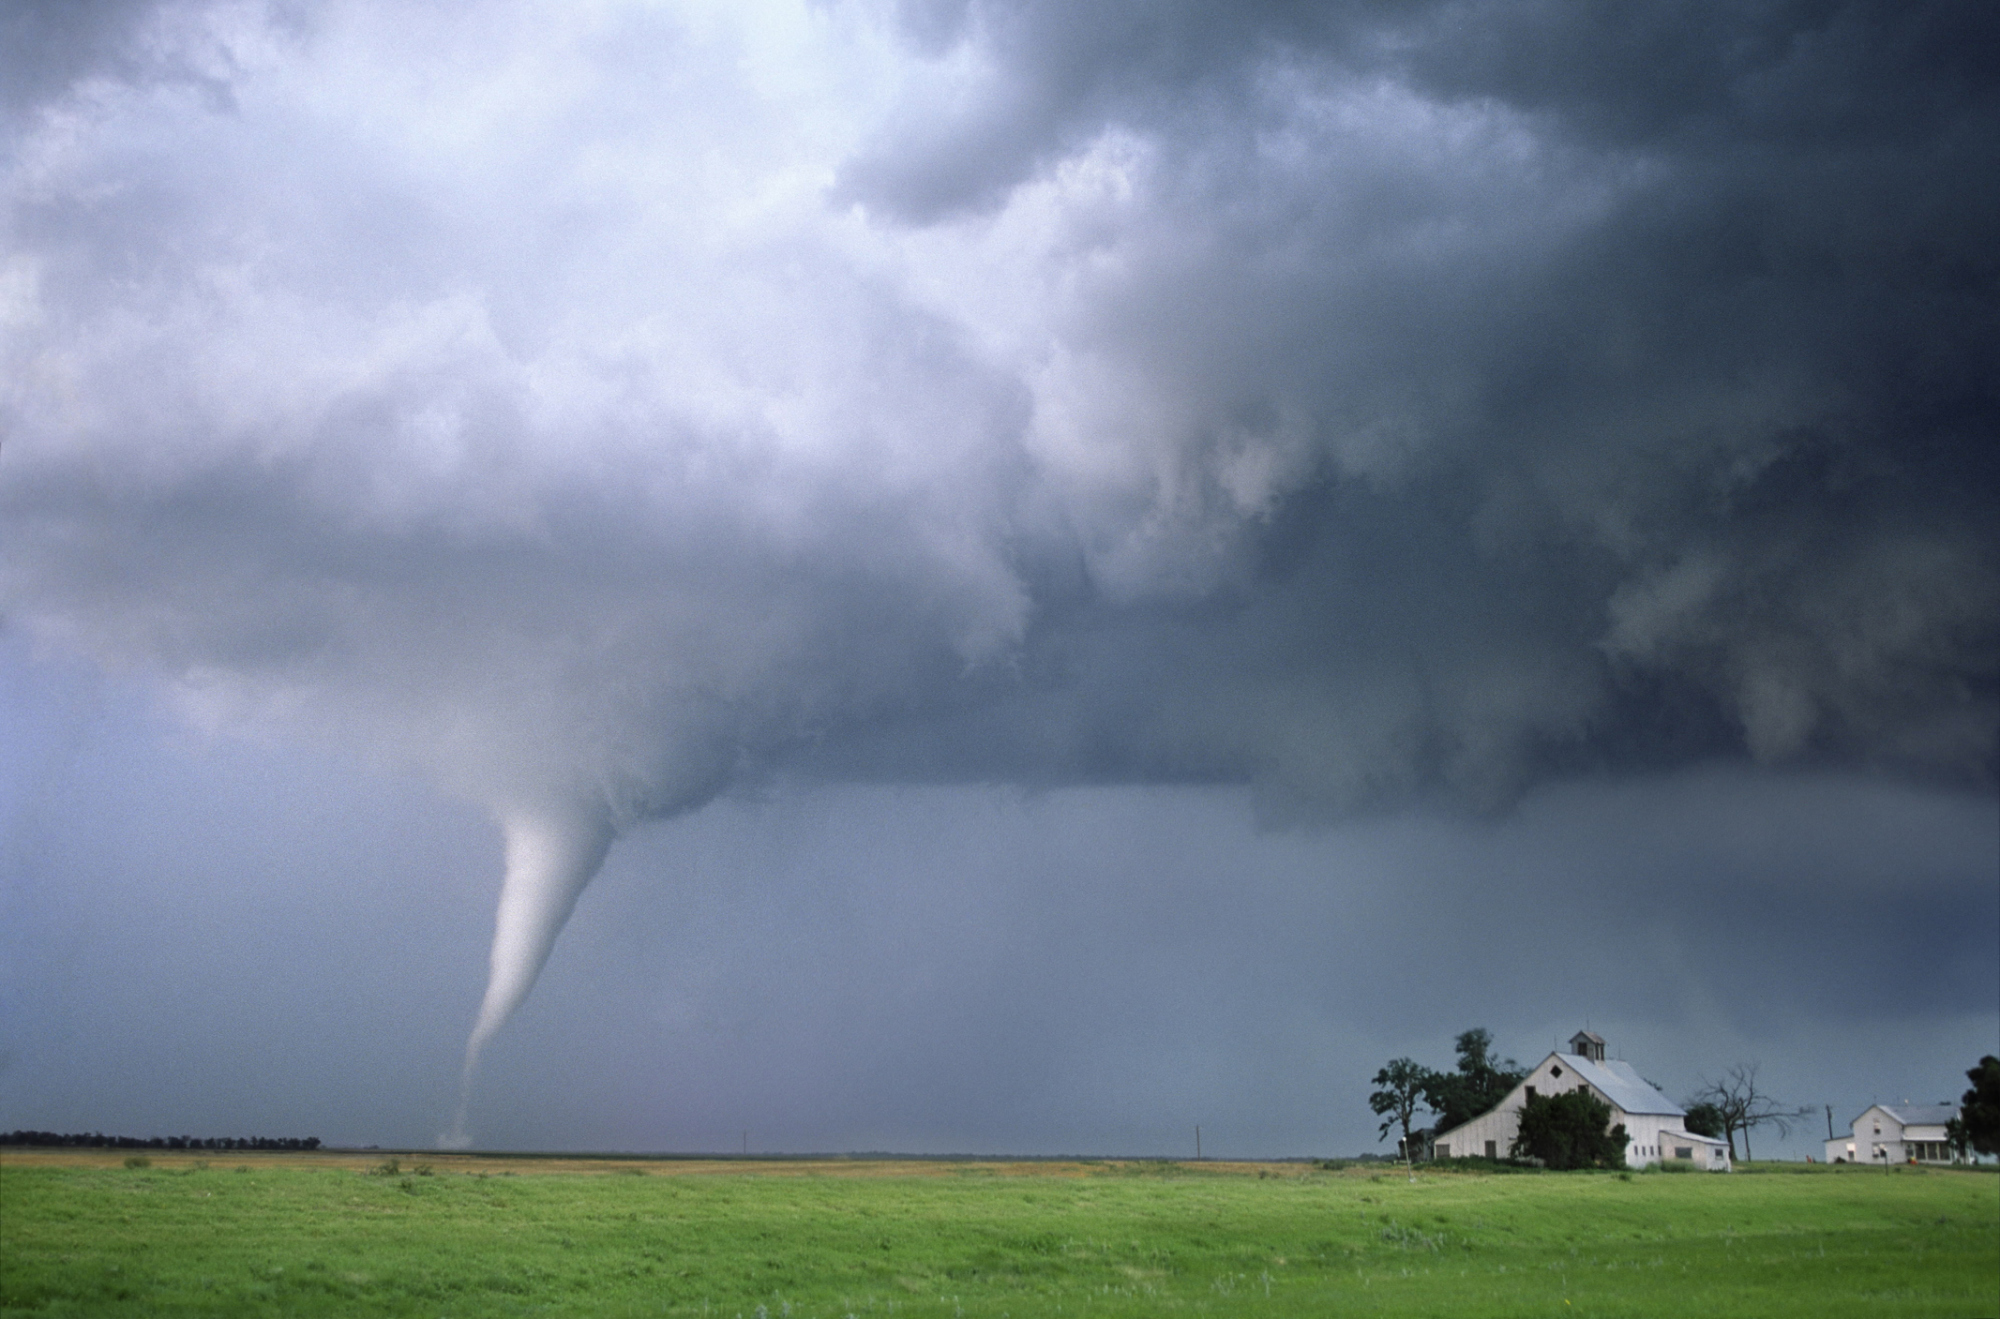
[1432,1031,1730,1171]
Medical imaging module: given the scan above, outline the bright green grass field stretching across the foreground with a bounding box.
[0,1153,2000,1319]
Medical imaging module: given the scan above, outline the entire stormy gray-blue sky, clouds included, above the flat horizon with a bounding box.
[0,0,2000,1153]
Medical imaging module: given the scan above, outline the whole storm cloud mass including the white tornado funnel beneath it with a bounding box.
[0,0,2000,1079]
